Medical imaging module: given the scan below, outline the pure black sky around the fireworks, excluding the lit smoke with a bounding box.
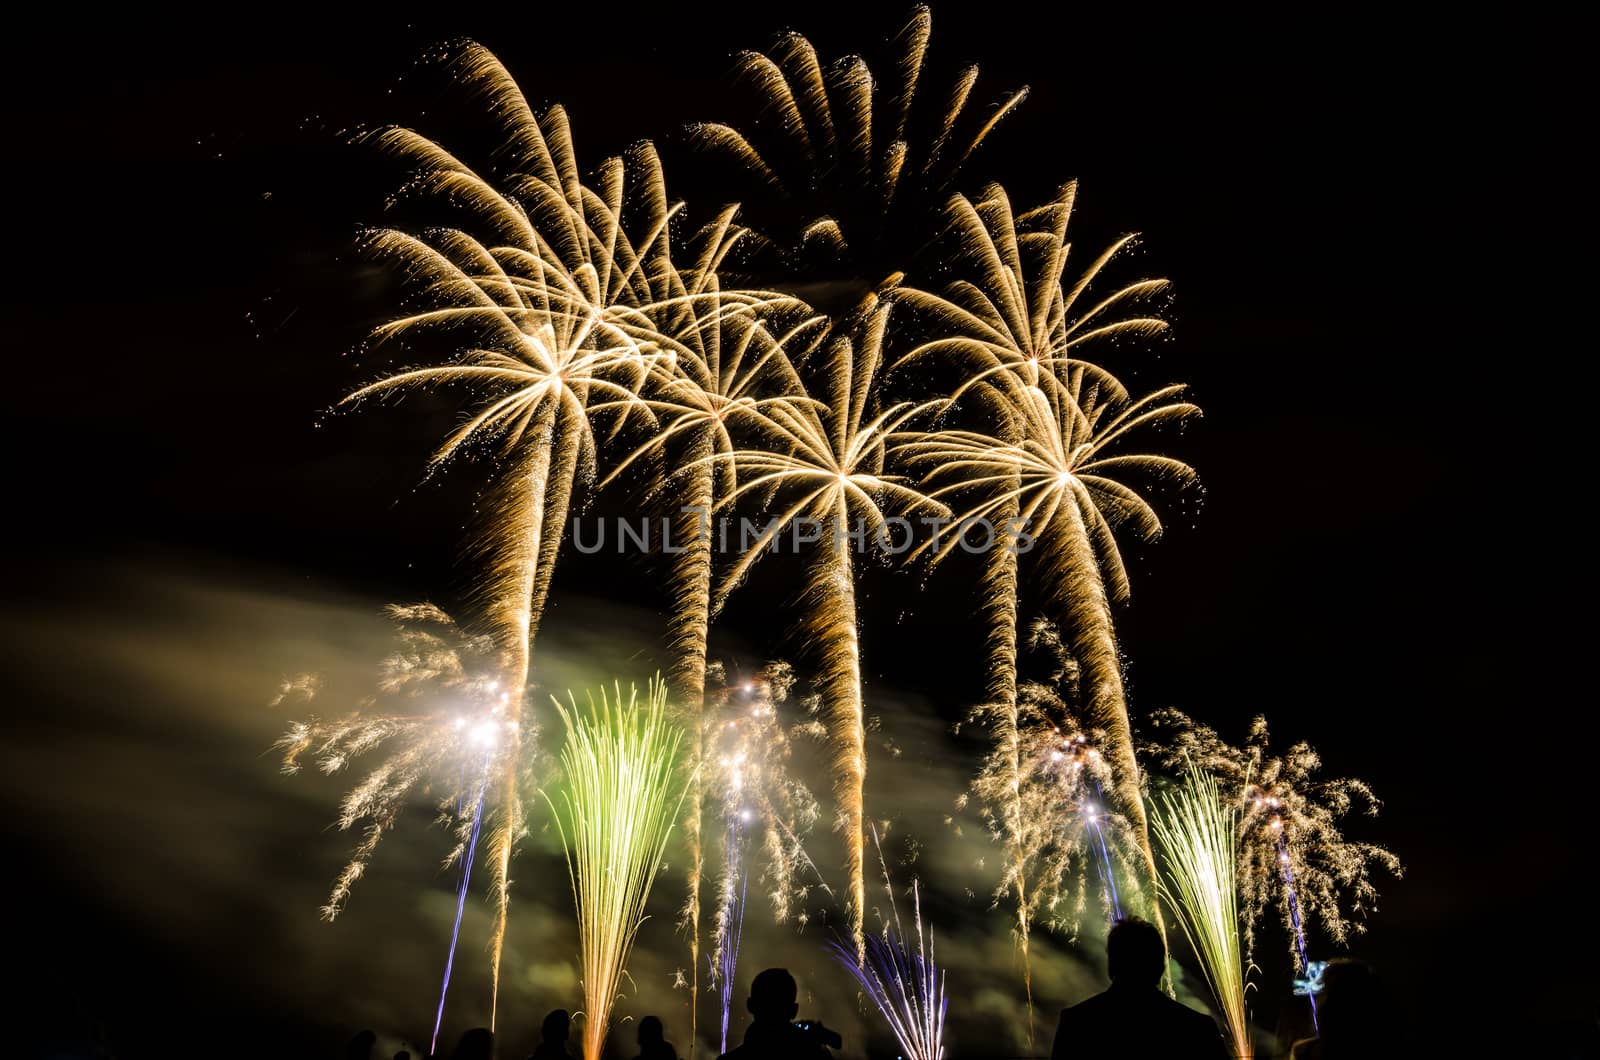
[0,3,1574,1055]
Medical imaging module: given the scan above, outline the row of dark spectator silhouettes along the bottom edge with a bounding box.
[346,917,1400,1060]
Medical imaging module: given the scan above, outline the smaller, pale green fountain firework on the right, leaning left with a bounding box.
[1150,769,1254,1060]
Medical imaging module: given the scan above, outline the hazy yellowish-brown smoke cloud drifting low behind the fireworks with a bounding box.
[0,568,1209,1055]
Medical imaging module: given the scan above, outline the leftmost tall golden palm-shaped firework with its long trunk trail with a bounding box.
[347,45,736,1025]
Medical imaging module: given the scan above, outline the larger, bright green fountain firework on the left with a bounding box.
[546,679,683,1060]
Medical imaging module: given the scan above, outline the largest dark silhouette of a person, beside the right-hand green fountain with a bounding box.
[1050,917,1229,1060]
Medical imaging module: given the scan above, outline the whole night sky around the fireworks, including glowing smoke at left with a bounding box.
[0,3,1580,1057]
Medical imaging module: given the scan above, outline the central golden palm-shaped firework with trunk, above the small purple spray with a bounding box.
[712,304,949,950]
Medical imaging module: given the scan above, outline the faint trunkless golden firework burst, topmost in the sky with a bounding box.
[693,8,1027,295]
